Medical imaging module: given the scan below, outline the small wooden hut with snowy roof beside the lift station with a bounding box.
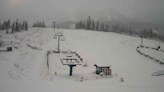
[94,64,112,75]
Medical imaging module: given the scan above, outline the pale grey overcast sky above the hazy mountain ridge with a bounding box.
[0,0,164,25]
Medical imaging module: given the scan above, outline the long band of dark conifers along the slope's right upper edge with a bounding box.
[75,16,164,40]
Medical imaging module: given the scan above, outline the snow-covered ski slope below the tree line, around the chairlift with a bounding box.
[0,28,164,92]
